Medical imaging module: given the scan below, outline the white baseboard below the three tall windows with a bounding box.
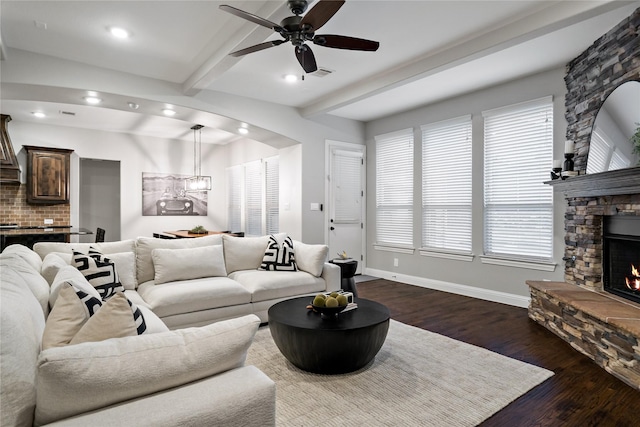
[364,268,530,308]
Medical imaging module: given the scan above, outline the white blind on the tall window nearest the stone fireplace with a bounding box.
[483,97,553,261]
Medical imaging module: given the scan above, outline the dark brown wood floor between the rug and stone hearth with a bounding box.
[357,279,640,427]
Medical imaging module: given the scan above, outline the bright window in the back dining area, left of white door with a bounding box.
[227,157,280,236]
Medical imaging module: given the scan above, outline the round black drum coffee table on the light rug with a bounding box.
[268,297,389,374]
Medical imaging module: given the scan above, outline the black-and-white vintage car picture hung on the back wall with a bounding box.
[142,172,208,216]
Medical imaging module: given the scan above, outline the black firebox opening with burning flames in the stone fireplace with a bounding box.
[603,215,640,303]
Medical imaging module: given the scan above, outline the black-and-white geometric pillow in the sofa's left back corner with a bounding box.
[73,247,124,300]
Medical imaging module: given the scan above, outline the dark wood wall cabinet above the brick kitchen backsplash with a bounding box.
[24,145,73,205]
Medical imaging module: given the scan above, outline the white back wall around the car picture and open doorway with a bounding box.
[9,120,290,239]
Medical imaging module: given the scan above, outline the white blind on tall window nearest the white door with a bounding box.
[375,129,413,247]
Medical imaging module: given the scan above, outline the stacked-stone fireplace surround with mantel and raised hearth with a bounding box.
[527,9,640,390]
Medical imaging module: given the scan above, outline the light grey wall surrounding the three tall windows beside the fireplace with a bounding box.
[366,68,566,305]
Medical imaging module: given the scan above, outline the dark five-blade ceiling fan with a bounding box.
[220,0,380,73]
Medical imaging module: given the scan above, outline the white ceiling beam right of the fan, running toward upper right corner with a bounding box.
[300,0,634,117]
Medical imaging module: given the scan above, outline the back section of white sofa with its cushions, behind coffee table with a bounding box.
[34,234,340,329]
